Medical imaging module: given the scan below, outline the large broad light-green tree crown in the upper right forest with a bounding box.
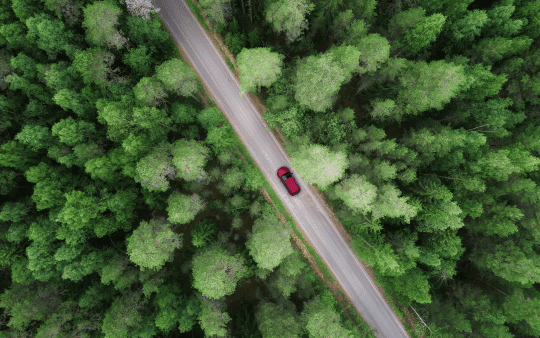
[395,60,465,120]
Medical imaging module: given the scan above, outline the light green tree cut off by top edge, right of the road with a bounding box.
[265,0,315,44]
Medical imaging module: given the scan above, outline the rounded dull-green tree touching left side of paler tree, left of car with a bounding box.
[136,144,175,191]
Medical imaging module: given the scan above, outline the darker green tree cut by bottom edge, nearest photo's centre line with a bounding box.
[255,300,303,338]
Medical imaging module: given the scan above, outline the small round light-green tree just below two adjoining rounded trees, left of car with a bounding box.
[167,191,206,224]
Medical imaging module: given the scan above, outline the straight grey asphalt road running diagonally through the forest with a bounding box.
[154,0,408,338]
